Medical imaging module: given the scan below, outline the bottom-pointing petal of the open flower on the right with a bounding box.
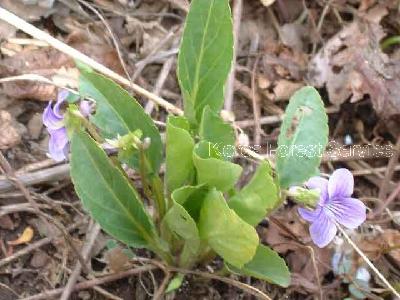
[310,211,337,248]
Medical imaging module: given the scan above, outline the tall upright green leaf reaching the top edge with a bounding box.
[178,0,233,124]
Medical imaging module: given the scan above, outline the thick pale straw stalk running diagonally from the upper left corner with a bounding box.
[0,7,183,115]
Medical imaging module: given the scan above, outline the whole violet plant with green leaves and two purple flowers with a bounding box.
[44,0,365,287]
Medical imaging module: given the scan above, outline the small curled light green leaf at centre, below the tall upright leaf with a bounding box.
[193,141,242,192]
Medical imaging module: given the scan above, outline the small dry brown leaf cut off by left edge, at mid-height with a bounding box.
[0,110,21,150]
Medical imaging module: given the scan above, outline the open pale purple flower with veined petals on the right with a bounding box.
[299,169,366,248]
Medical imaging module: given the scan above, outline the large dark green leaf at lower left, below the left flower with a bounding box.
[71,132,155,247]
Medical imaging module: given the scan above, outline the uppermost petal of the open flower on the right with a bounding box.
[328,168,354,199]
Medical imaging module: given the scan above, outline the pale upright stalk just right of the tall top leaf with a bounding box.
[224,0,243,111]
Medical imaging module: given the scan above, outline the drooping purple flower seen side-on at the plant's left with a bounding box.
[43,90,93,161]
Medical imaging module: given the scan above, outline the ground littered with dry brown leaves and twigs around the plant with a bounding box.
[0,0,400,300]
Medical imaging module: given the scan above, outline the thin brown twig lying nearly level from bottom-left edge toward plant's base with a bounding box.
[21,265,157,300]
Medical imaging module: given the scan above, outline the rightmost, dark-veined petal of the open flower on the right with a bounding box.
[324,198,367,229]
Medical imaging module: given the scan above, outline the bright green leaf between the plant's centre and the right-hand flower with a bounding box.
[228,162,279,226]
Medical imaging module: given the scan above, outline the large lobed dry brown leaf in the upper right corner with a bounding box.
[309,5,400,117]
